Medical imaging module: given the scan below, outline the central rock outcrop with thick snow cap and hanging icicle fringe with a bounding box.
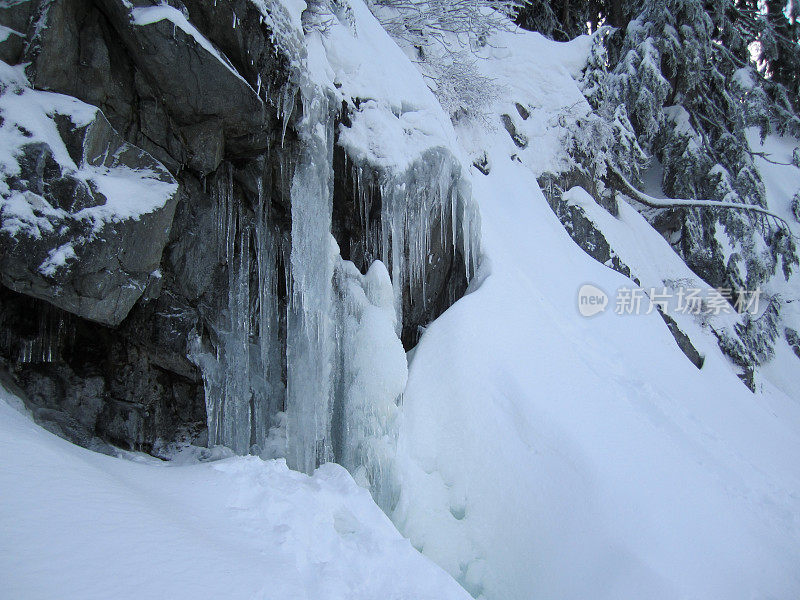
[306,0,480,348]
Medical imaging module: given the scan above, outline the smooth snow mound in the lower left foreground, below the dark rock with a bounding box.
[0,388,468,600]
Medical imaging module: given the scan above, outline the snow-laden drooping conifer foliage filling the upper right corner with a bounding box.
[517,0,800,366]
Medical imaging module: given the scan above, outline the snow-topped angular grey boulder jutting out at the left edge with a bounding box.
[0,63,178,325]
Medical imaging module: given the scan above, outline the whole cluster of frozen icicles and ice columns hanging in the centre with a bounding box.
[193,82,477,506]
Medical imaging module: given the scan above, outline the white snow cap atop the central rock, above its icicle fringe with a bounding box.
[307,0,461,172]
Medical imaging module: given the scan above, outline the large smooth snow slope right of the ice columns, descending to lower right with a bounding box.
[393,23,800,600]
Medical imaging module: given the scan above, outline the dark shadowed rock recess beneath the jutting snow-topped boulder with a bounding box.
[0,289,205,453]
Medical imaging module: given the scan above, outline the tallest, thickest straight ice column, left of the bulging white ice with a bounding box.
[286,87,335,473]
